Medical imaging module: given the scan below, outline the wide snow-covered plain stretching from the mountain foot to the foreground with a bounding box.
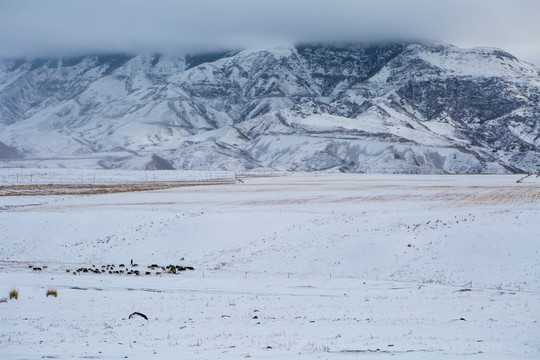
[0,169,540,359]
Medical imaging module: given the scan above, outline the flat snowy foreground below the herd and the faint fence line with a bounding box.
[1,274,540,359]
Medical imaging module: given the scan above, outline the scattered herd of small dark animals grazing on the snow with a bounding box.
[29,260,195,276]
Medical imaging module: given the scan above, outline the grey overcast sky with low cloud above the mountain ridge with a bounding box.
[0,0,540,66]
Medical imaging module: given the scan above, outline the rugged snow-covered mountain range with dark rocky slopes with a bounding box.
[0,43,540,173]
